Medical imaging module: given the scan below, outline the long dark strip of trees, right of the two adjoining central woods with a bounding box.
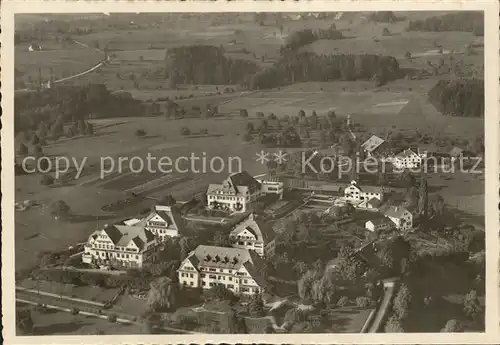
[245,52,400,89]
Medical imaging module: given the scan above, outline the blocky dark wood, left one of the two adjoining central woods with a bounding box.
[164,45,259,88]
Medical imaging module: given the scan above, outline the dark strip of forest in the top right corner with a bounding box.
[408,12,484,36]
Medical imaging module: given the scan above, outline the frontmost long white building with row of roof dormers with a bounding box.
[177,245,266,295]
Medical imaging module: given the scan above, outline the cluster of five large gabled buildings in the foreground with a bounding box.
[82,172,283,294]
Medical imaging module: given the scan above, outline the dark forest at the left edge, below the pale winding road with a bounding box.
[14,84,140,135]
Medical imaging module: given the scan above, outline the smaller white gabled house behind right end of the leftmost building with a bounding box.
[144,205,184,241]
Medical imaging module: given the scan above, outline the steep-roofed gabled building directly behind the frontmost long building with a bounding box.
[229,213,276,256]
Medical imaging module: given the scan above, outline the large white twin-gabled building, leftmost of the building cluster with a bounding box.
[82,224,158,268]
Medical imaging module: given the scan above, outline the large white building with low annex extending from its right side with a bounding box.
[207,171,283,213]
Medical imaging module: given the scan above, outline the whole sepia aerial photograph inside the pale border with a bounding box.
[13,11,486,336]
